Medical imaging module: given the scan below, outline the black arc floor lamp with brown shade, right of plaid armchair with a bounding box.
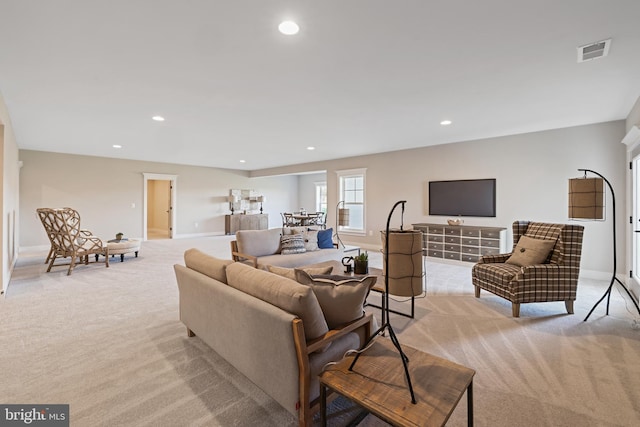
[569,169,640,322]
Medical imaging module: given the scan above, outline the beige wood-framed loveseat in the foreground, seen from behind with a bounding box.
[174,249,375,426]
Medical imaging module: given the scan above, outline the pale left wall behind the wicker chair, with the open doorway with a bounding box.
[20,150,298,248]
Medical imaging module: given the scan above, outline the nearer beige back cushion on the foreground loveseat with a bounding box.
[227,262,329,341]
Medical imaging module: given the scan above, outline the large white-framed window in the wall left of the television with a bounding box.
[338,169,366,234]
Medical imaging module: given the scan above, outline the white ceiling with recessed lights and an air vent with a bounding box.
[0,0,640,170]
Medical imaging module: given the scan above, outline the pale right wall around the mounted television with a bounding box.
[252,121,628,277]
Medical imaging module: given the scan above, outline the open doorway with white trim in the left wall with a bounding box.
[143,173,177,240]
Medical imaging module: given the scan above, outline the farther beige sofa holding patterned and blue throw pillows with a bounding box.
[231,227,344,267]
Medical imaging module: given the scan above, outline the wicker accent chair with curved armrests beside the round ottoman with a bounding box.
[37,208,109,276]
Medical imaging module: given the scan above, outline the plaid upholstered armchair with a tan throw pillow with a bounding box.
[471,221,584,317]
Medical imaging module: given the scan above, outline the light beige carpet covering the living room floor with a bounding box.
[0,236,640,426]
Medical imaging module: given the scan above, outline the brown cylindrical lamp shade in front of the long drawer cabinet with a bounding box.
[382,230,422,297]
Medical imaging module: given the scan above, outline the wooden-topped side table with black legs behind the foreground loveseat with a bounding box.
[319,337,475,426]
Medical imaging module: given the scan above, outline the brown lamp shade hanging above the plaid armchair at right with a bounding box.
[569,178,604,219]
